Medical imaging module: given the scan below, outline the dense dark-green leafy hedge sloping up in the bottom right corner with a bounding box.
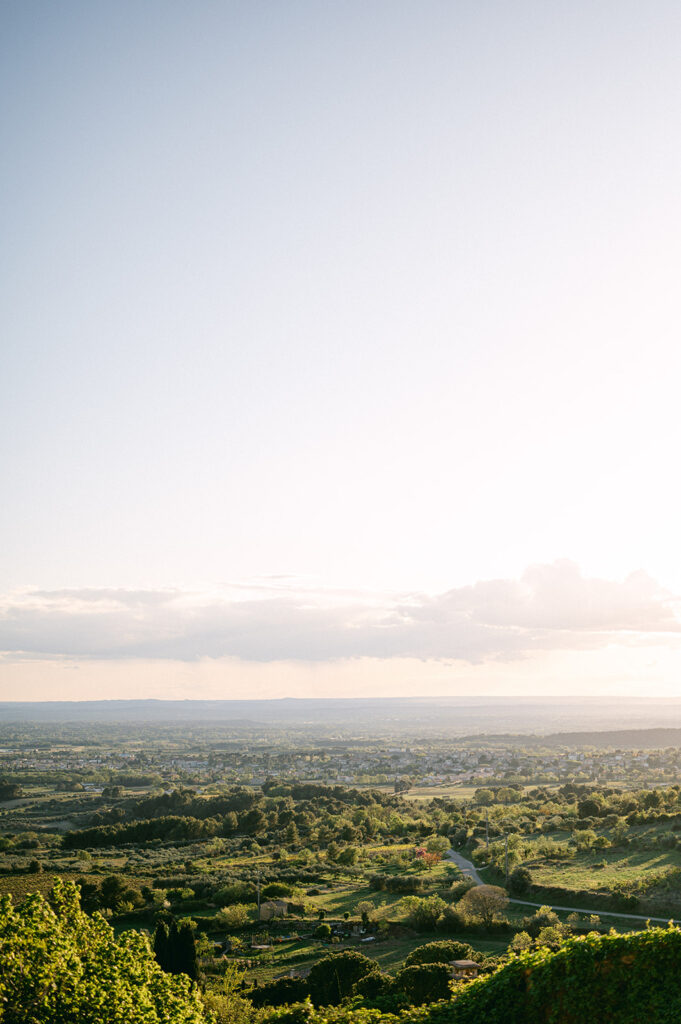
[270,928,681,1024]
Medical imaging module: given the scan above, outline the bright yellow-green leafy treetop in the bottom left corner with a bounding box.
[0,882,211,1024]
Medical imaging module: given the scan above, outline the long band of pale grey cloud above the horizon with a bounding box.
[0,560,681,664]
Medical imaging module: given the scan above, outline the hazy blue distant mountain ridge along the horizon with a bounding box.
[0,695,681,745]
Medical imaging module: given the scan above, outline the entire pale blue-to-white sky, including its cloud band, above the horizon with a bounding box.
[0,0,681,699]
